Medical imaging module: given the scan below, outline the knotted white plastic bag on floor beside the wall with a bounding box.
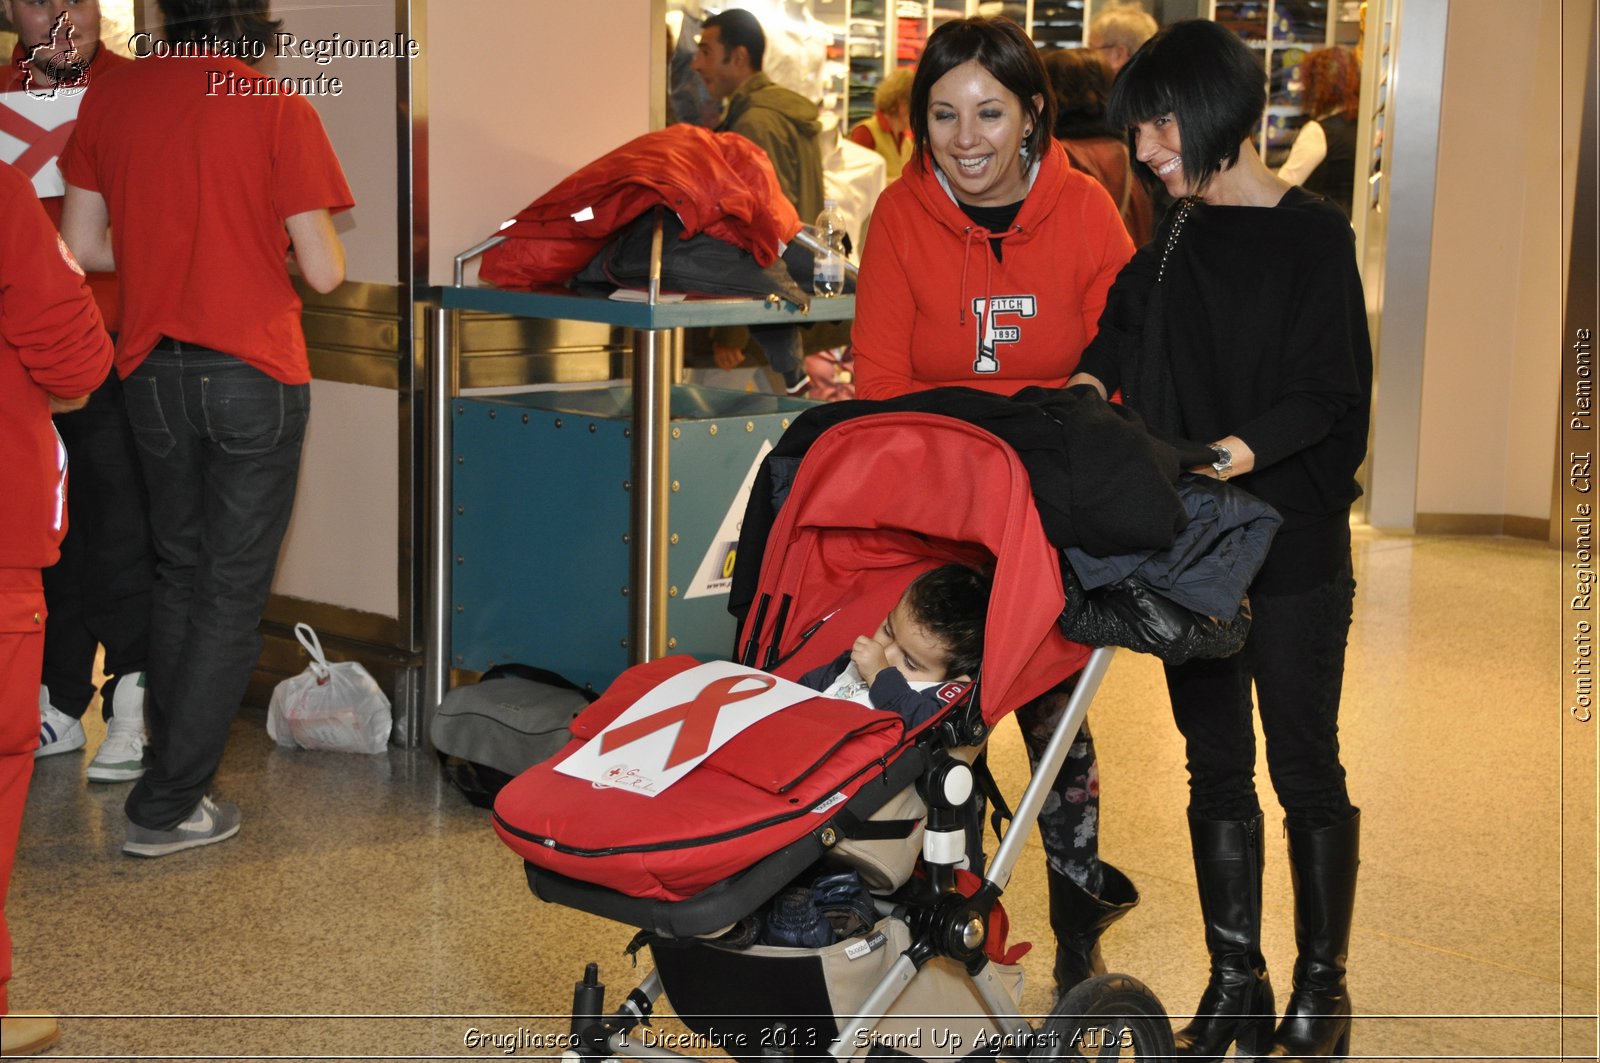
[267,624,394,752]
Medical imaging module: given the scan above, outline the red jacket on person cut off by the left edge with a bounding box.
[0,163,110,568]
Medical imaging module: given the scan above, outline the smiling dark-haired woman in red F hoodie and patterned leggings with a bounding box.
[851,18,1139,993]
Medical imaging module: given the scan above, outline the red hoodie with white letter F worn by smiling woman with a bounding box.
[851,141,1133,399]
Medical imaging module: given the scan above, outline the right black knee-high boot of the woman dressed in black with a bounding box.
[1267,810,1362,1060]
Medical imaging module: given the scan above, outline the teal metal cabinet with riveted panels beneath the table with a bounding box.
[451,386,811,690]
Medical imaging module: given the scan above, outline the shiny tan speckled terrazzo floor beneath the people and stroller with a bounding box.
[8,533,1595,1060]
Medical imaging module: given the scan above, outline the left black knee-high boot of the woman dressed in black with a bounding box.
[1173,815,1277,1060]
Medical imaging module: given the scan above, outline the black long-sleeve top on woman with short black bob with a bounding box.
[1078,187,1373,592]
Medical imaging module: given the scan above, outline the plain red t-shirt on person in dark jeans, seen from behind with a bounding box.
[61,56,355,384]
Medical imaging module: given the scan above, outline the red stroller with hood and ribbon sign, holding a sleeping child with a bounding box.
[494,413,1173,1060]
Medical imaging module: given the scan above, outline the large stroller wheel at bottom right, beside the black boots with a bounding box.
[1029,975,1174,1060]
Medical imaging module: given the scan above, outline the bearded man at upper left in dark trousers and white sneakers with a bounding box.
[0,0,155,783]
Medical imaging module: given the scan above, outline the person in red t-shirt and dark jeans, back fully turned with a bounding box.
[62,0,354,856]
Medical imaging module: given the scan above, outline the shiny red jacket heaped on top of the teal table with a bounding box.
[478,125,800,290]
